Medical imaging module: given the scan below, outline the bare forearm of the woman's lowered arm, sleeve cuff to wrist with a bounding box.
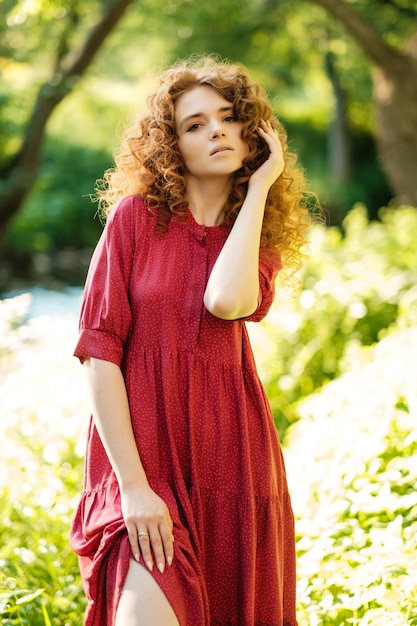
[84,358,147,490]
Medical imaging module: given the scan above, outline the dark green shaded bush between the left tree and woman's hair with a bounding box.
[4,138,105,284]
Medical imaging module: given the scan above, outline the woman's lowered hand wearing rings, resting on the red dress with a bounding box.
[121,484,174,573]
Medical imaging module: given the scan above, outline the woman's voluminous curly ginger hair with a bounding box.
[96,56,312,275]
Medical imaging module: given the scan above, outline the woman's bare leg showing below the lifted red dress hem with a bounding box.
[114,559,180,626]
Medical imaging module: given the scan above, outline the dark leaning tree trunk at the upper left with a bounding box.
[0,0,132,244]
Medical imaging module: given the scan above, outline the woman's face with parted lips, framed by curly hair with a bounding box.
[175,86,249,180]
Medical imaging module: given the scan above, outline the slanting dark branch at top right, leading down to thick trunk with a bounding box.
[311,0,405,73]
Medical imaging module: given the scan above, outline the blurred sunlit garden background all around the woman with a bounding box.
[0,0,417,626]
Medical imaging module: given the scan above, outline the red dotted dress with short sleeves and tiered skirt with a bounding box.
[71,197,297,626]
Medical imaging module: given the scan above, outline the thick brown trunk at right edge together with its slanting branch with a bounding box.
[313,0,417,206]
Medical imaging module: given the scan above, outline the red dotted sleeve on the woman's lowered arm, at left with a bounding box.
[74,198,137,366]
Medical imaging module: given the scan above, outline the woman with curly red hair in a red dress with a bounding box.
[71,58,307,626]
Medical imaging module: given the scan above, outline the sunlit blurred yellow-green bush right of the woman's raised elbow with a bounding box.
[249,205,417,435]
